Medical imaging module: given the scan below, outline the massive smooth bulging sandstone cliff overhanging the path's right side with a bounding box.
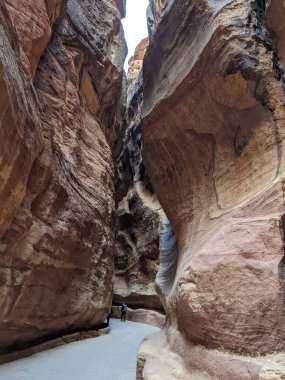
[139,0,285,379]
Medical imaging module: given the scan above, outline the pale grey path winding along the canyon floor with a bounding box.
[0,319,159,380]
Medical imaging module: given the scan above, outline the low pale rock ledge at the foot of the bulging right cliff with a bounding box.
[137,326,285,380]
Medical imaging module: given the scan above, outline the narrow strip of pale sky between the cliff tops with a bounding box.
[122,0,148,71]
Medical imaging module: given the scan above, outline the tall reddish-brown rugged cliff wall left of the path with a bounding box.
[0,0,125,350]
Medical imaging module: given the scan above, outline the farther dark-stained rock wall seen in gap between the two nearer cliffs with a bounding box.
[114,39,162,309]
